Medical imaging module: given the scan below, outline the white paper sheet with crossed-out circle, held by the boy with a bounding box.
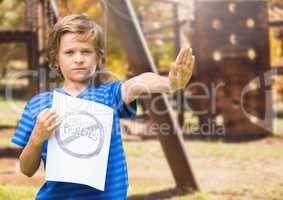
[46,91,113,191]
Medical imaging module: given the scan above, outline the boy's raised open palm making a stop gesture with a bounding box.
[168,47,195,91]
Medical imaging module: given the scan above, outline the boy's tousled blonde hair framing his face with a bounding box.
[48,14,105,84]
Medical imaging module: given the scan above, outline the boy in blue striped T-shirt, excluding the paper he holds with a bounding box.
[12,15,195,200]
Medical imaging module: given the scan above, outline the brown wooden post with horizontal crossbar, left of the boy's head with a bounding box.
[0,0,58,96]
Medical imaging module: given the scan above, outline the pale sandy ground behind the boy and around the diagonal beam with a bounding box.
[0,129,283,200]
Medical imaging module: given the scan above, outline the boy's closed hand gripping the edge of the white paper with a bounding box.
[31,109,61,145]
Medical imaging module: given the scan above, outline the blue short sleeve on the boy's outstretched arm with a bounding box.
[114,81,137,119]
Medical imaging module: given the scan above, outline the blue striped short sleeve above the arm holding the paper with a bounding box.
[11,104,35,147]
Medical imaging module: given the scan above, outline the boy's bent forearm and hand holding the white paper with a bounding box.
[19,109,60,177]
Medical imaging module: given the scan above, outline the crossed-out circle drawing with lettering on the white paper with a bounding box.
[55,111,105,158]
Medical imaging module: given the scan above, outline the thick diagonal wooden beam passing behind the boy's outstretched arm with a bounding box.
[106,0,198,190]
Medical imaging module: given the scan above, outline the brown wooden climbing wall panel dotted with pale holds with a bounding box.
[190,0,272,137]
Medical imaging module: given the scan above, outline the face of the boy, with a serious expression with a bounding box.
[58,33,97,83]
